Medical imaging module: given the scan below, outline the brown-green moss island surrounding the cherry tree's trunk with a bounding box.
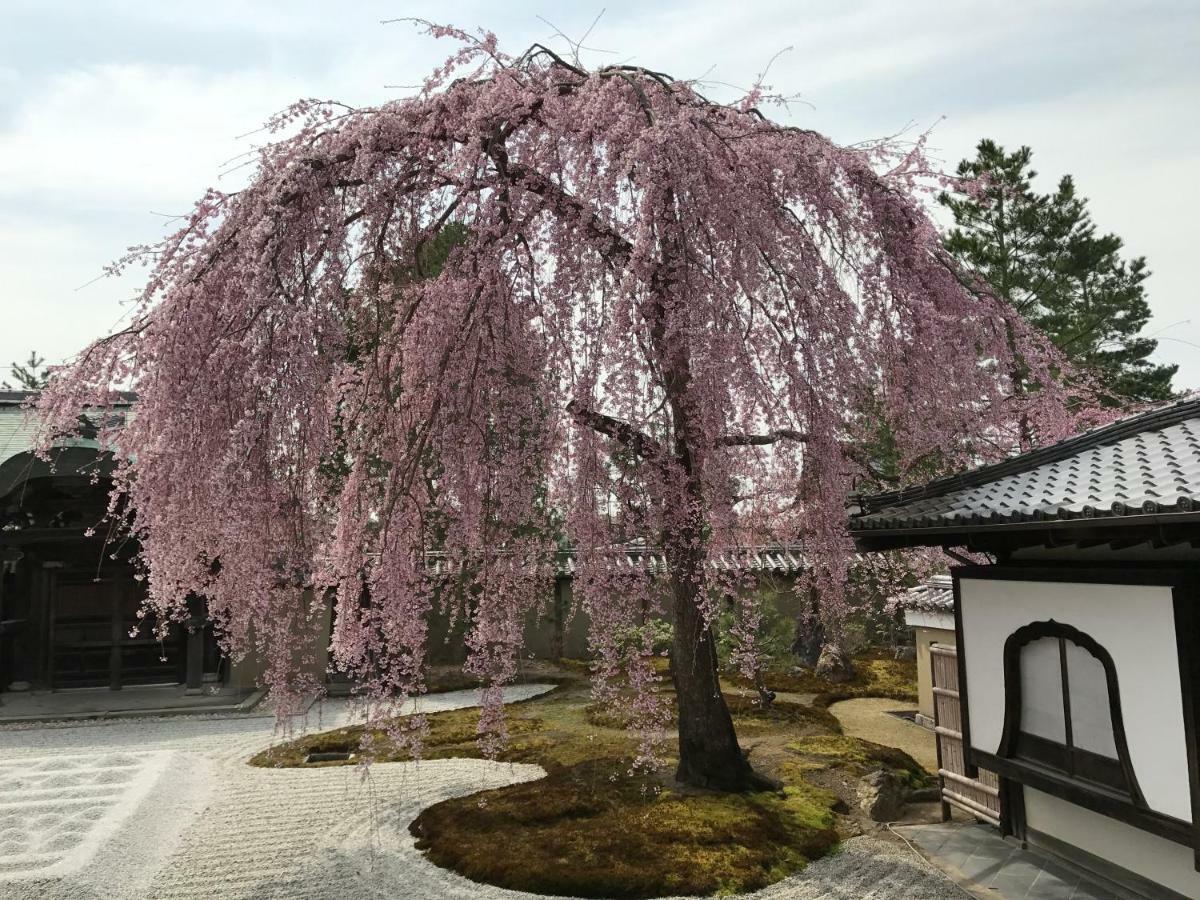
[251,660,929,898]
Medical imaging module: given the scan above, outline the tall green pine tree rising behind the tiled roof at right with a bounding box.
[940,140,1177,406]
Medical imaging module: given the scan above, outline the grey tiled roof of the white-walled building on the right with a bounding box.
[850,398,1200,536]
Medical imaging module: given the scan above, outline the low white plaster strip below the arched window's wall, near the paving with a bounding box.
[1025,787,1200,898]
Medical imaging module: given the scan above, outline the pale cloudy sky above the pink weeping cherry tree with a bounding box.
[0,0,1200,388]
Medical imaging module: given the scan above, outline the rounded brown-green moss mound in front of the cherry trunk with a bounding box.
[409,760,838,898]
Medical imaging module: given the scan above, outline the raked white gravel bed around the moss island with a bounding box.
[0,685,964,900]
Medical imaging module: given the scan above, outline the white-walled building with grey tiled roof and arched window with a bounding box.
[850,400,1200,898]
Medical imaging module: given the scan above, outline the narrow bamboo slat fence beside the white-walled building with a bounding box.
[929,643,1000,826]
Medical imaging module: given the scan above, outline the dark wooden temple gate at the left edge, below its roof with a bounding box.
[0,446,213,694]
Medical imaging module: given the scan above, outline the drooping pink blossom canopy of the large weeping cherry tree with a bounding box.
[40,28,1072,746]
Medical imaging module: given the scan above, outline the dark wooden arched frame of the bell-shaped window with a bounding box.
[997,619,1147,809]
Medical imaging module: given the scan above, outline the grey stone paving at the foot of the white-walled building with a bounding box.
[895,822,1120,900]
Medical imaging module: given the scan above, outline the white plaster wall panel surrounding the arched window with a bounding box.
[960,577,1192,822]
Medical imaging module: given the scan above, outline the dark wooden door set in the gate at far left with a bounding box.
[49,571,184,690]
